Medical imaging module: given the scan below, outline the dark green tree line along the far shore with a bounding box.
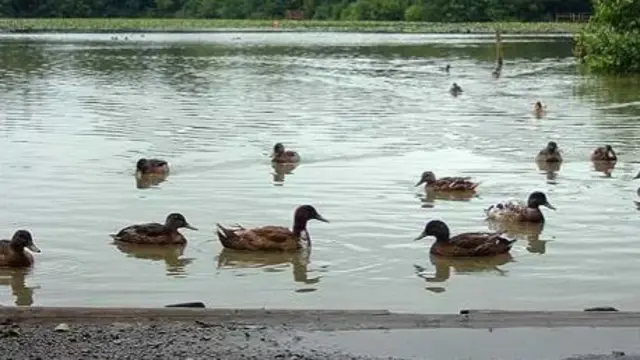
[0,0,591,22]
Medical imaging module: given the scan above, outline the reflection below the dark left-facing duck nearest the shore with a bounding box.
[413,253,513,293]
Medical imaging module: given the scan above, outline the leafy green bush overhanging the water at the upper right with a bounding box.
[575,0,640,74]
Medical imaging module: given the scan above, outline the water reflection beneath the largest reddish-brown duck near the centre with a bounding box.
[217,248,321,284]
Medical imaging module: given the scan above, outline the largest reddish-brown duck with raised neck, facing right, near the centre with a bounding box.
[216,205,329,251]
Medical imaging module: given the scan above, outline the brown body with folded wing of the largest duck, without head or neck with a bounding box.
[216,224,300,251]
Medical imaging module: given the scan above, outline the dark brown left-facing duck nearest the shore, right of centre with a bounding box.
[414,220,516,257]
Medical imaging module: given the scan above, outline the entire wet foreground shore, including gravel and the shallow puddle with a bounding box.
[0,307,640,360]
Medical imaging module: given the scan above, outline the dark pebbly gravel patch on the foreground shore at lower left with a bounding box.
[0,321,400,360]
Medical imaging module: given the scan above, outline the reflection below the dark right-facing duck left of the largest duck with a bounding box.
[114,242,194,276]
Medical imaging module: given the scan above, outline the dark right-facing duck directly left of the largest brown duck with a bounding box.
[110,213,198,245]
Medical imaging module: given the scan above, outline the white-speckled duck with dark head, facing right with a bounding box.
[485,191,556,223]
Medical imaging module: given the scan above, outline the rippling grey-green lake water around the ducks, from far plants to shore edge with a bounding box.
[0,33,640,312]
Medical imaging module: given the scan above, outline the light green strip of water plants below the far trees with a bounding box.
[0,18,583,34]
